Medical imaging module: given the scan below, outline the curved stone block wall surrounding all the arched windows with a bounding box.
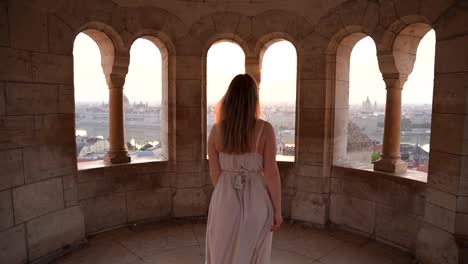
[0,0,468,264]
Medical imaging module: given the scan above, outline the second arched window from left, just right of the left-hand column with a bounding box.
[124,38,167,160]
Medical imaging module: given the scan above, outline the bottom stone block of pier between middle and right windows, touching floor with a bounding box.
[291,191,327,225]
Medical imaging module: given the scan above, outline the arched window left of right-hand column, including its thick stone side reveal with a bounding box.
[333,33,386,169]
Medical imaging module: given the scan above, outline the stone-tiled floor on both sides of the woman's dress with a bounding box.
[54,220,412,264]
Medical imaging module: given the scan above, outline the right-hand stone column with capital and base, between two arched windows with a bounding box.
[374,74,408,173]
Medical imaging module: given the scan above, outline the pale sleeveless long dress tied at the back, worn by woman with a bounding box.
[205,123,274,264]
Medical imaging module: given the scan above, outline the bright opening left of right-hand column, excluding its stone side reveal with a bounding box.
[346,37,386,168]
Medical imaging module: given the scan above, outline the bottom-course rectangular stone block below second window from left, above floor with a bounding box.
[127,188,172,222]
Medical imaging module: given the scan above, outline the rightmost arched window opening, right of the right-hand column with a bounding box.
[400,30,435,173]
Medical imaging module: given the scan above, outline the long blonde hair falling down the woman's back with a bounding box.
[216,74,260,154]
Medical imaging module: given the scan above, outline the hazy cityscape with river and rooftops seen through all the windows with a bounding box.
[75,97,432,172]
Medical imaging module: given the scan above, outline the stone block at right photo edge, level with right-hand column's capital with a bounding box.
[433,73,468,114]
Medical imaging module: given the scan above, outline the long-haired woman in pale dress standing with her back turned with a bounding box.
[205,74,283,264]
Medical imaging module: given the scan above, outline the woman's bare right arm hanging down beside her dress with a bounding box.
[263,122,282,230]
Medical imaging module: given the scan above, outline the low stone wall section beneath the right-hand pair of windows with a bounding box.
[330,167,426,252]
